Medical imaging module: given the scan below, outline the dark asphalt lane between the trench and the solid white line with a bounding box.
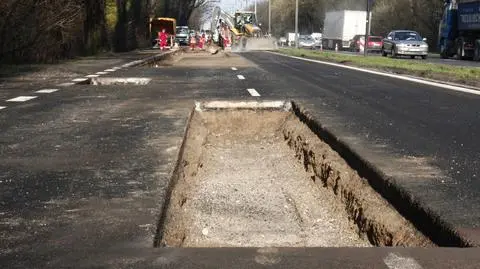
[243,49,480,226]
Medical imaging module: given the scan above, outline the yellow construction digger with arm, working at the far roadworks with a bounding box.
[211,6,276,51]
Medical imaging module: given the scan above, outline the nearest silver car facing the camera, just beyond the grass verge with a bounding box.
[382,30,428,59]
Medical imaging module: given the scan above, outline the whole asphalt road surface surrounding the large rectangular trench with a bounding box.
[0,49,480,269]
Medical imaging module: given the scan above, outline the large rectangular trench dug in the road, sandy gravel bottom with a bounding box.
[155,102,434,247]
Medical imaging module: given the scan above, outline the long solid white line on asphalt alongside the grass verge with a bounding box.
[268,52,480,95]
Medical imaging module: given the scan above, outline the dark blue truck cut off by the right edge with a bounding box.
[438,0,480,61]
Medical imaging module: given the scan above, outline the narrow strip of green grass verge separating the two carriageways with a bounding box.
[277,48,480,87]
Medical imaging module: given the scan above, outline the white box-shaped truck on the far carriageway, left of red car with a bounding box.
[322,10,367,49]
